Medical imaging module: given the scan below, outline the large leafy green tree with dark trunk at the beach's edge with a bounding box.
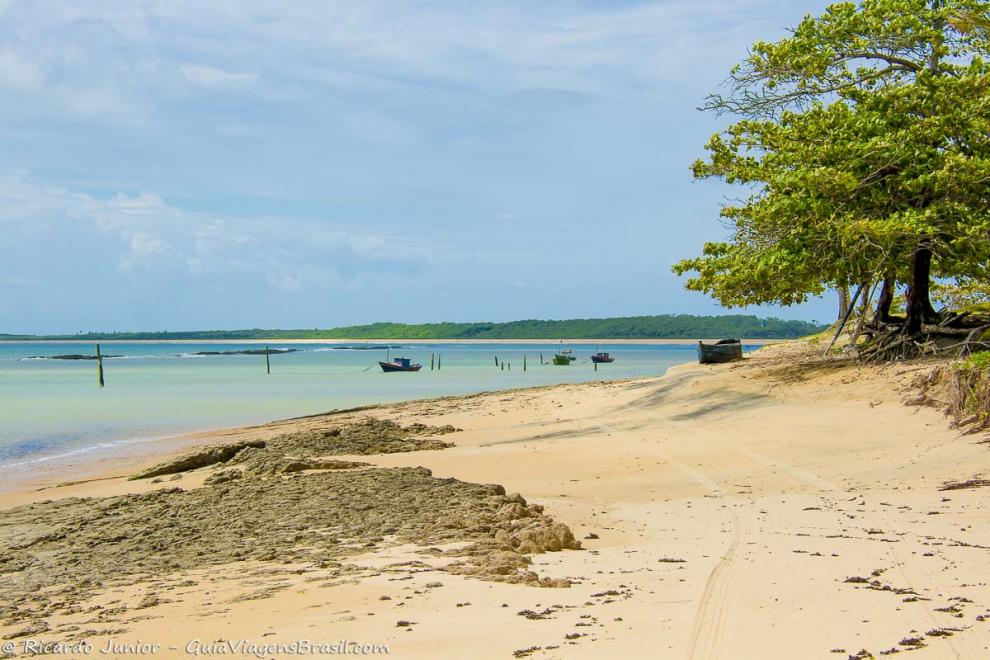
[674,0,990,334]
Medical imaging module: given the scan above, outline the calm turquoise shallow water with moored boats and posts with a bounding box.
[0,342,695,468]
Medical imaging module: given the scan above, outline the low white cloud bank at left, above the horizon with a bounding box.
[0,173,440,291]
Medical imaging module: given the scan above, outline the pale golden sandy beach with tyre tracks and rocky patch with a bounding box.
[0,340,990,659]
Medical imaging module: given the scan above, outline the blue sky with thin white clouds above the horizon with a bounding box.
[0,0,836,333]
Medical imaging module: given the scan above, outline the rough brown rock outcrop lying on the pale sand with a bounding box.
[0,418,581,633]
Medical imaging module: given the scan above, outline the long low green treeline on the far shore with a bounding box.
[0,314,826,340]
